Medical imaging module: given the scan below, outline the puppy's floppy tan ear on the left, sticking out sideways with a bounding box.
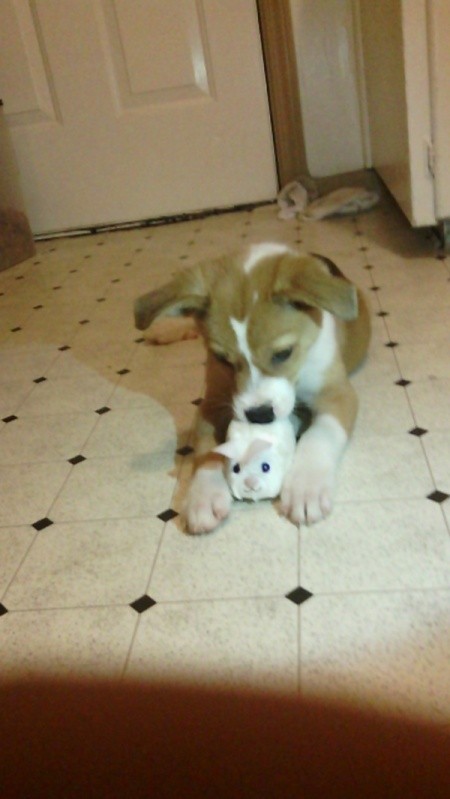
[134,266,210,330]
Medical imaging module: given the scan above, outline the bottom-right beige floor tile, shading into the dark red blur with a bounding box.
[300,591,450,721]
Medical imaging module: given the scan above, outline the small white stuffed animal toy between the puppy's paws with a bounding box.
[214,414,300,502]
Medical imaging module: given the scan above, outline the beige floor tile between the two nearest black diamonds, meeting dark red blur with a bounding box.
[126,598,298,691]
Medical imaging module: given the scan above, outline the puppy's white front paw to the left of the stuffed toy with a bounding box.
[184,469,231,534]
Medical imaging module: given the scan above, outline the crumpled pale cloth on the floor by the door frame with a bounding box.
[277,178,380,220]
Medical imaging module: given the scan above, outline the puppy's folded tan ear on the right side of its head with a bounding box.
[272,254,358,321]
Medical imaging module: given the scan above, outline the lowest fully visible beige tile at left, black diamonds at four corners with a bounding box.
[4,519,163,614]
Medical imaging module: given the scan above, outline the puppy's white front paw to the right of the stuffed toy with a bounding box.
[280,469,334,526]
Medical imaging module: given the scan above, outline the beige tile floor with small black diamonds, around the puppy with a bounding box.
[0,201,450,723]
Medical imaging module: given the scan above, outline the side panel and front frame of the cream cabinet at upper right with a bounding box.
[356,0,434,226]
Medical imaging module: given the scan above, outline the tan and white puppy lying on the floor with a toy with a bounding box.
[135,243,370,533]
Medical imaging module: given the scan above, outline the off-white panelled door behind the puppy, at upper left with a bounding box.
[0,0,277,233]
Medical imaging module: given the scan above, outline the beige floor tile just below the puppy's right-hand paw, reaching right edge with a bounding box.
[300,498,450,594]
